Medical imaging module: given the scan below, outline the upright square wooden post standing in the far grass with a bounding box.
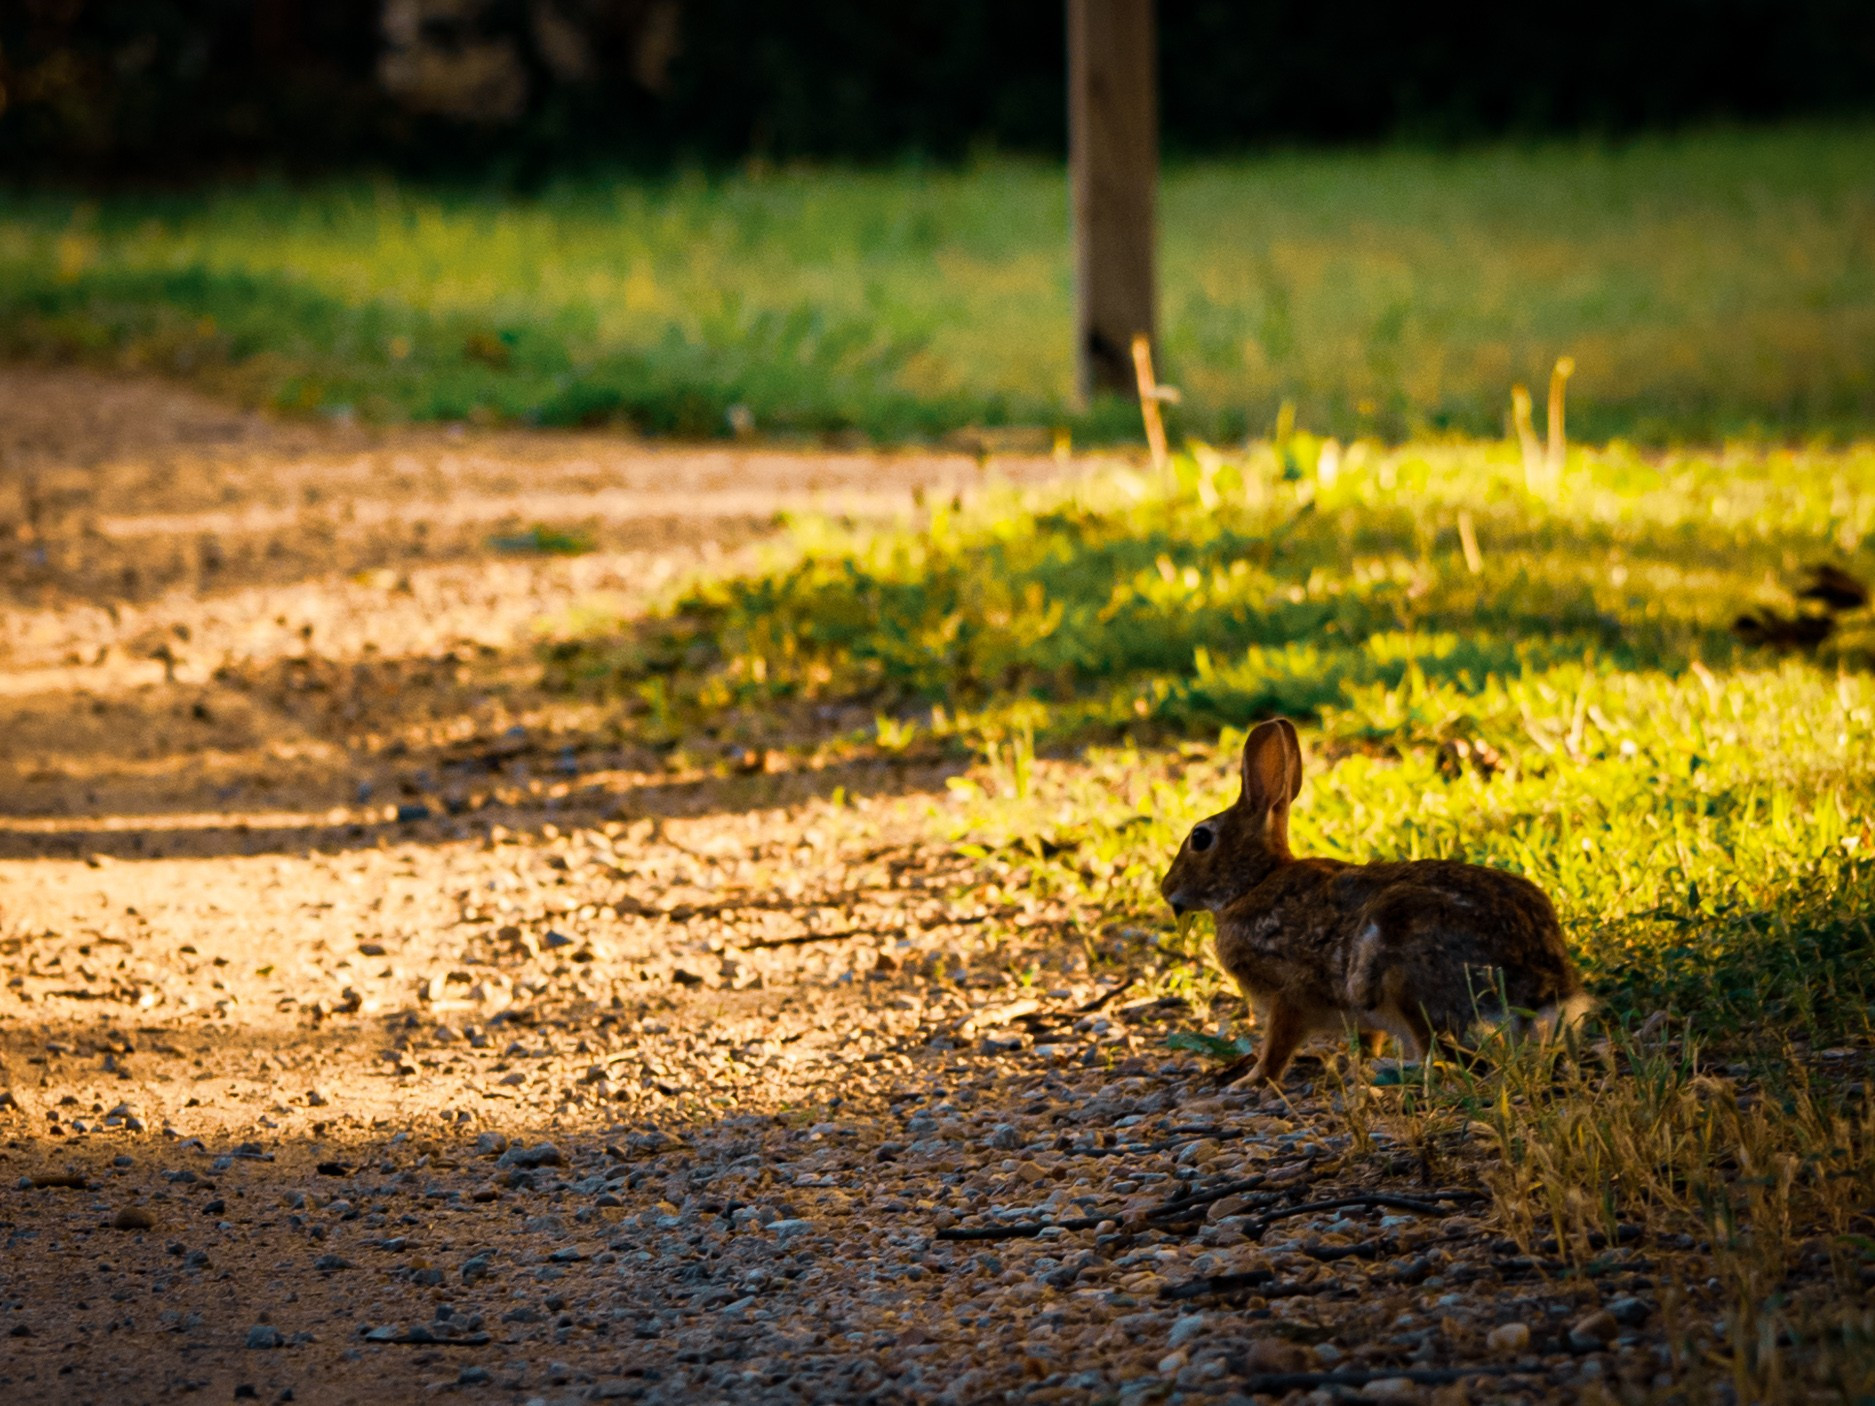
[1067,0,1159,399]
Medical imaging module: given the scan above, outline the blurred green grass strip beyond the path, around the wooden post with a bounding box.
[0,126,1875,442]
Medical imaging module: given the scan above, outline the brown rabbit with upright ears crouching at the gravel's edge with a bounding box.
[1159,718,1588,1084]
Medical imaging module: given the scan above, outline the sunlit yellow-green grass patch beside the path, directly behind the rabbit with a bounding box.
[549,439,1875,1044]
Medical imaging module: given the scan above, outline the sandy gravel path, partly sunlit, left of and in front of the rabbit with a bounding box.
[0,369,1661,1402]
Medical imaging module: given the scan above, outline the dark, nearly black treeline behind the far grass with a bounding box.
[0,0,1875,180]
